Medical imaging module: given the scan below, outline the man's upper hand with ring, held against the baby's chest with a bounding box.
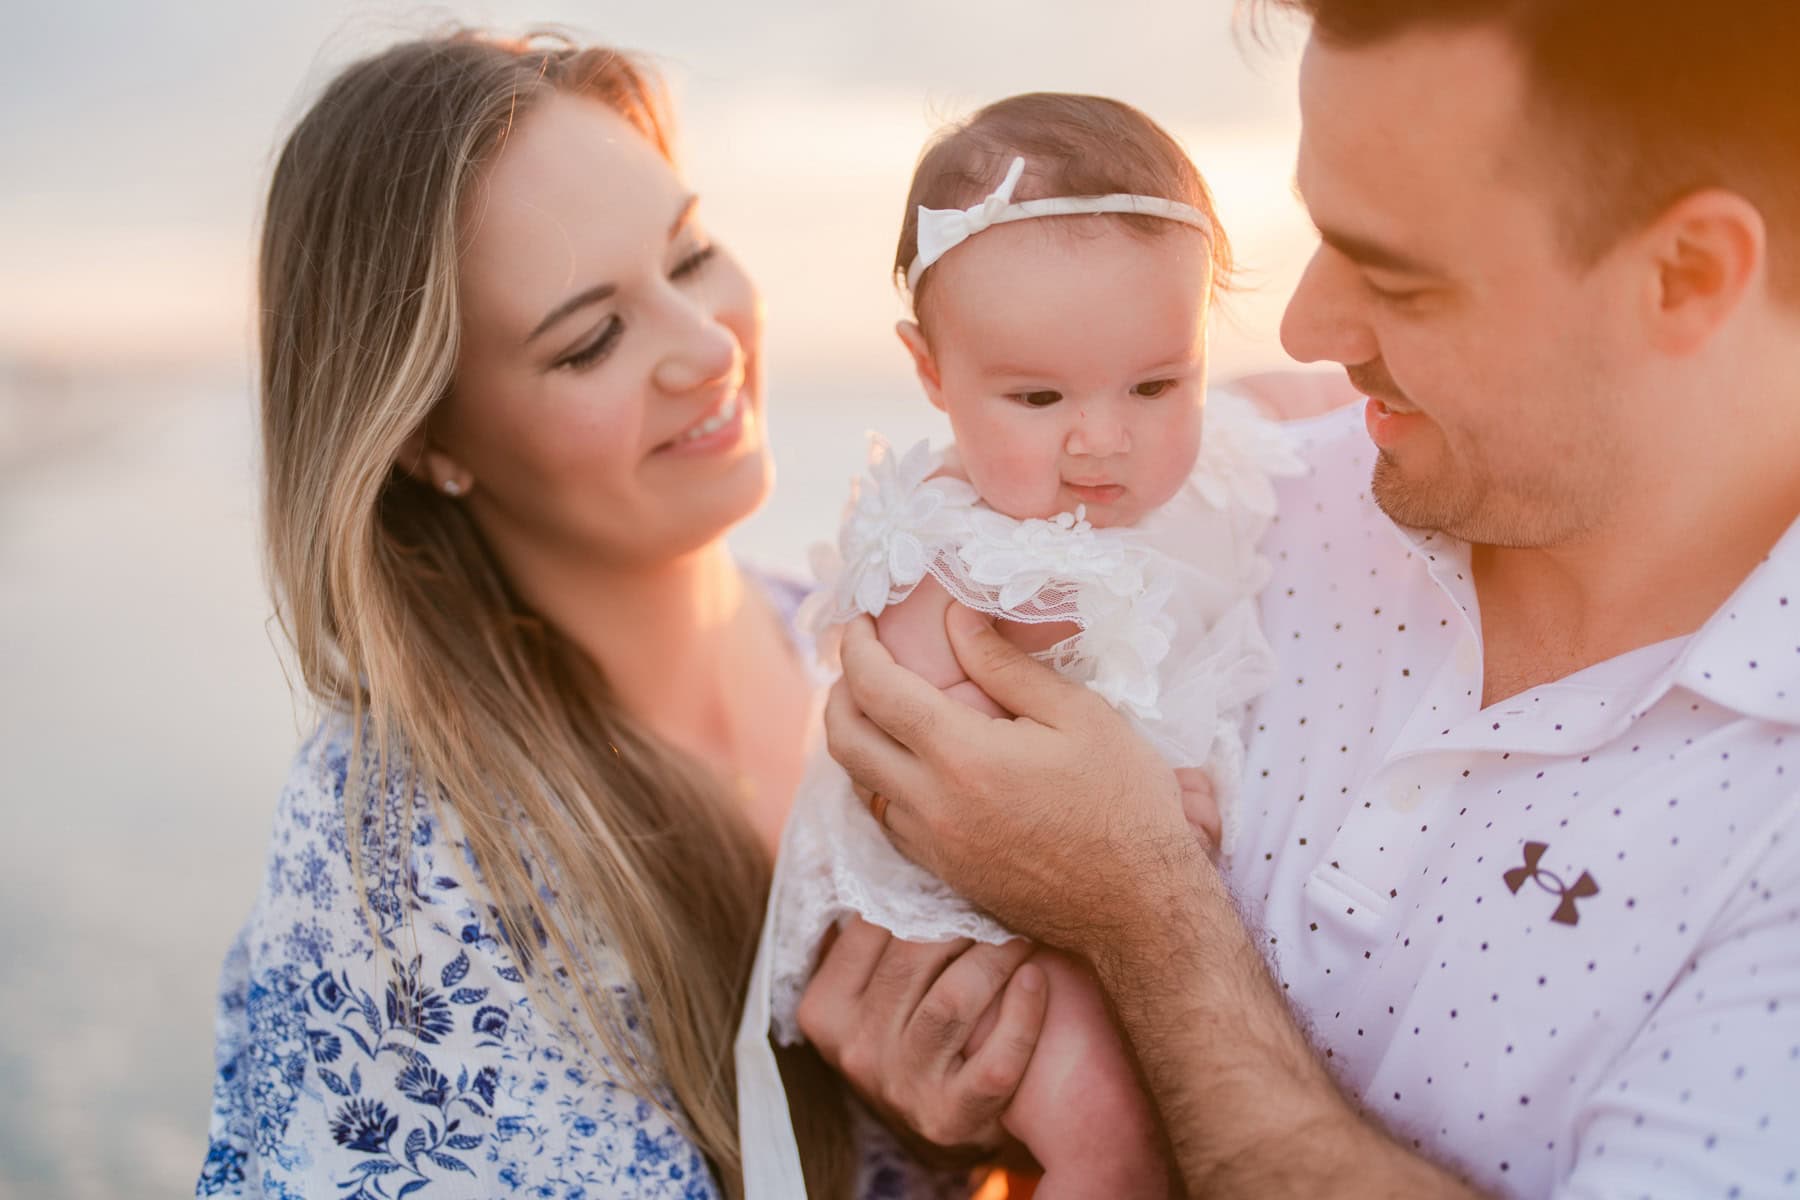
[824,604,1204,957]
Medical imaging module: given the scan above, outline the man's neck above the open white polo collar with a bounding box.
[1471,446,1800,705]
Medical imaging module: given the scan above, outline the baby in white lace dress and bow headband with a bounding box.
[740,94,1298,1200]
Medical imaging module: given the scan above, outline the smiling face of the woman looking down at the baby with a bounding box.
[442,94,772,578]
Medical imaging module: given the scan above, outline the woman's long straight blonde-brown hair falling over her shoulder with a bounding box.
[259,32,850,1195]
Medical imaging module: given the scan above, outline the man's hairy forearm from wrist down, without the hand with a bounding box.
[1093,851,1474,1196]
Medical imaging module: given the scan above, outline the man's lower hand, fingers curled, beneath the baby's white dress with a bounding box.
[797,919,1049,1162]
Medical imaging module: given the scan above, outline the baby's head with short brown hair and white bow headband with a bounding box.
[895,94,1231,525]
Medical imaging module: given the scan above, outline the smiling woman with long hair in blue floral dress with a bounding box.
[200,34,1030,1200]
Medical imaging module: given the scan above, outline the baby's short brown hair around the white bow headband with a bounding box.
[895,92,1231,322]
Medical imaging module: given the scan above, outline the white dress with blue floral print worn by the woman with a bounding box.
[196,579,968,1200]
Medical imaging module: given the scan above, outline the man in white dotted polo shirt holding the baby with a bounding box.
[808,0,1800,1196]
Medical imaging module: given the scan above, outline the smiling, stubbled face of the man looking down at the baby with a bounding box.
[1282,29,1643,547]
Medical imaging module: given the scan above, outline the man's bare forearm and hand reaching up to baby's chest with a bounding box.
[826,610,1471,1196]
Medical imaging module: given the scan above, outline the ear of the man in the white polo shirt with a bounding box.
[1642,189,1768,356]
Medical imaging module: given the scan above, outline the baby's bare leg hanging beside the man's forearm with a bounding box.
[1001,950,1170,1200]
